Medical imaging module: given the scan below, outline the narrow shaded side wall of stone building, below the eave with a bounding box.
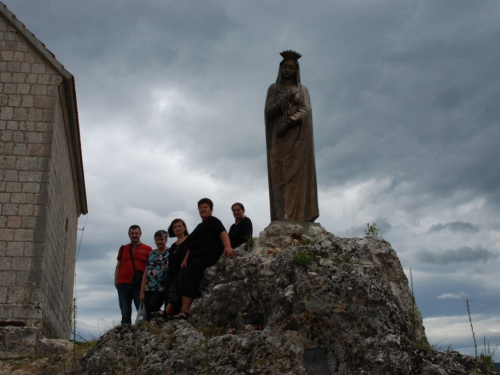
[42,99,78,338]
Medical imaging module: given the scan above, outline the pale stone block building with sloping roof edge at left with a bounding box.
[0,2,87,358]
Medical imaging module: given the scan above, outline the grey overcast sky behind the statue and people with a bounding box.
[3,0,500,353]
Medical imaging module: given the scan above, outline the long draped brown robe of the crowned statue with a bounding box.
[265,82,319,222]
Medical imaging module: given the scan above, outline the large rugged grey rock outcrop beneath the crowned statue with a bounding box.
[72,224,482,375]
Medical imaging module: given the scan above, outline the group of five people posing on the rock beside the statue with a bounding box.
[115,198,253,324]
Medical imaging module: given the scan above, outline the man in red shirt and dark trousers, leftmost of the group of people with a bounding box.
[115,225,153,324]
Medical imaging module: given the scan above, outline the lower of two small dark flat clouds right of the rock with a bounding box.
[416,246,497,265]
